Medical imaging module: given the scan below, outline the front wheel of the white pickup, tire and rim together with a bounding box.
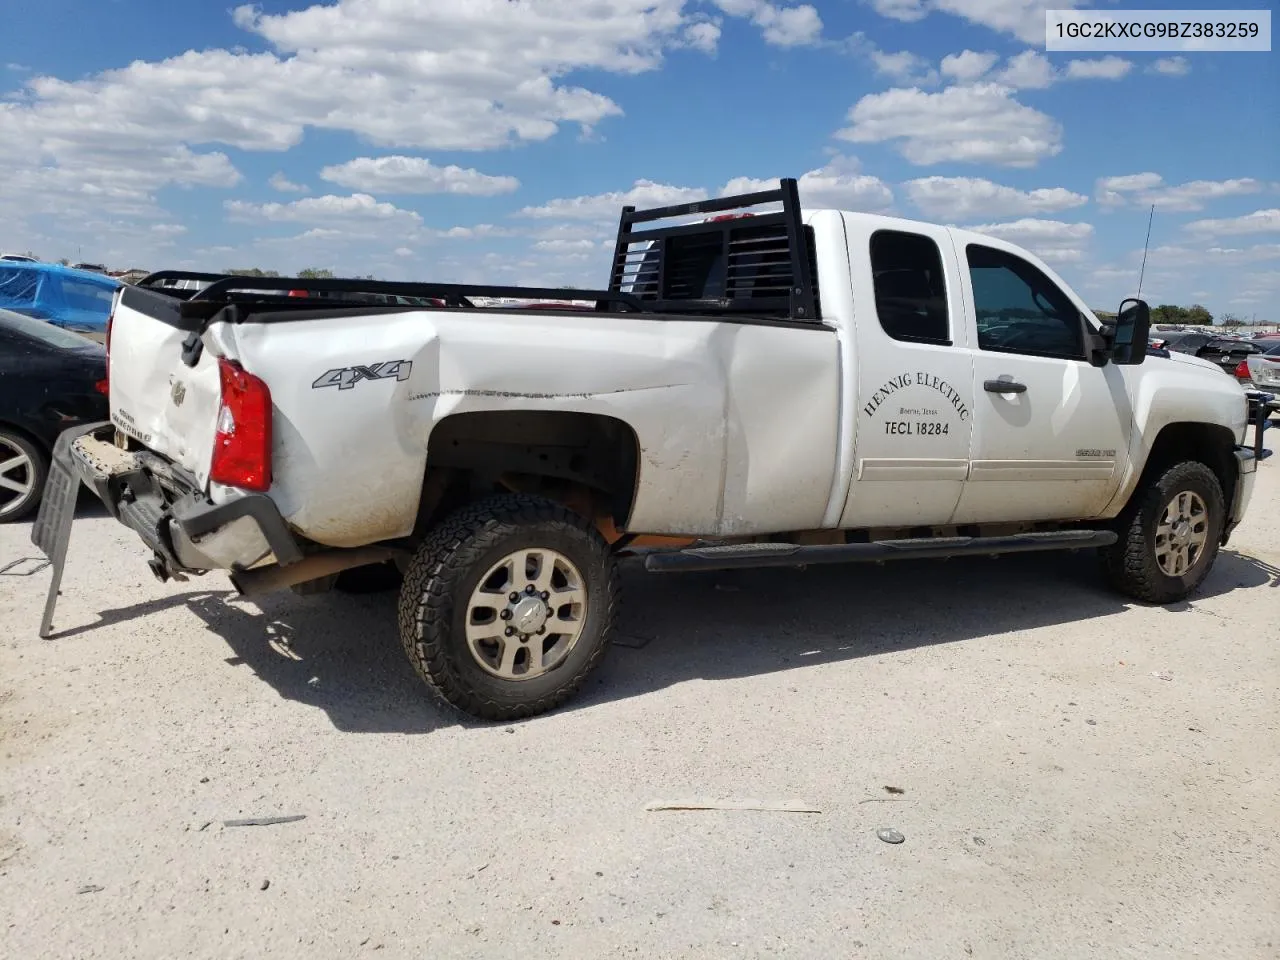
[1101,461,1226,603]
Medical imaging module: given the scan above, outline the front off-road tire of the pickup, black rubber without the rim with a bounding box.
[1098,461,1226,603]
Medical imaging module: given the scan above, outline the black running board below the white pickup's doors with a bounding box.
[644,530,1119,573]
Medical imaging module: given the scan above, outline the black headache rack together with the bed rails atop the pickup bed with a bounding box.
[127,179,820,325]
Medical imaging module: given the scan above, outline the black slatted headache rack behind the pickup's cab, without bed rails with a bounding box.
[609,179,822,323]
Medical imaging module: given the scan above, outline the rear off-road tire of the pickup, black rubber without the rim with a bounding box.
[399,494,620,721]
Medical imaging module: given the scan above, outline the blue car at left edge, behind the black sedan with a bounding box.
[0,261,122,334]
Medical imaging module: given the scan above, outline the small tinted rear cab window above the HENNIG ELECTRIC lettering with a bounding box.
[870,230,951,347]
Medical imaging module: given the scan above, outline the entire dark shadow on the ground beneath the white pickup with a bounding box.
[145,550,1280,733]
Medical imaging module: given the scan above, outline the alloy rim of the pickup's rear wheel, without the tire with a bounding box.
[466,548,588,680]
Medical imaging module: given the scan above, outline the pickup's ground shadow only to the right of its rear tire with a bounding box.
[567,550,1280,709]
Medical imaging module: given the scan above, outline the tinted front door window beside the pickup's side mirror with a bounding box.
[965,243,1084,360]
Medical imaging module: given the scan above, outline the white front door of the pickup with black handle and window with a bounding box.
[955,239,1133,524]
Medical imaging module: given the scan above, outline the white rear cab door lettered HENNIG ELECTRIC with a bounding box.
[840,218,973,529]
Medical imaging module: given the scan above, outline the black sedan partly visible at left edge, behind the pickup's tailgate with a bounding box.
[0,310,109,524]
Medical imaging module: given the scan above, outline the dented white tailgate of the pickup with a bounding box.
[108,287,221,488]
